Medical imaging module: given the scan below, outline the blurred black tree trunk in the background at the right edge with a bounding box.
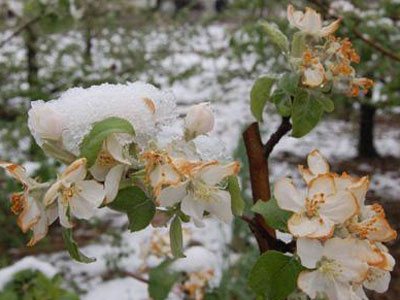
[358,103,379,158]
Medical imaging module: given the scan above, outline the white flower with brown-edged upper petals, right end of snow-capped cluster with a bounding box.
[157,162,239,226]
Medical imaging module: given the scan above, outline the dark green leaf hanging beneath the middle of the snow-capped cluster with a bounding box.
[108,186,156,231]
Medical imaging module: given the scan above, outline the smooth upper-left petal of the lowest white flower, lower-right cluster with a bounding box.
[297,238,324,269]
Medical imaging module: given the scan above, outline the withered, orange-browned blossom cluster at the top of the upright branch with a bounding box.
[287,5,373,96]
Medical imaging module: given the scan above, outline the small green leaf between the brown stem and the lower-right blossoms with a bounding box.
[251,198,293,232]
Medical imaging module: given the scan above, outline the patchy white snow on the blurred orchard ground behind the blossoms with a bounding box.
[0,26,400,300]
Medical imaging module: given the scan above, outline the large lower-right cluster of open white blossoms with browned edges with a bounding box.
[274,150,397,300]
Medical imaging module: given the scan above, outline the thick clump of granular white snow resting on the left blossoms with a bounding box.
[29,82,175,155]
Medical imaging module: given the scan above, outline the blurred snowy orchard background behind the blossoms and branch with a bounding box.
[0,0,400,300]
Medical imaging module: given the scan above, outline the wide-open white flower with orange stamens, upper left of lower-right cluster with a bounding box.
[274,174,358,239]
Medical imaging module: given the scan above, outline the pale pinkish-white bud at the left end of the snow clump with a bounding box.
[28,101,65,145]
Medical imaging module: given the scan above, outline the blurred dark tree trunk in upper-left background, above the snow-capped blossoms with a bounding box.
[25,26,39,88]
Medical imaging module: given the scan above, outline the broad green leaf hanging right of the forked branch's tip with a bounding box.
[292,90,323,138]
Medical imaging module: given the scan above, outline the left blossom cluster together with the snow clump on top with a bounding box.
[0,82,239,246]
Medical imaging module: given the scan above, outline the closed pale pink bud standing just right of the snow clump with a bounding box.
[185,103,214,139]
